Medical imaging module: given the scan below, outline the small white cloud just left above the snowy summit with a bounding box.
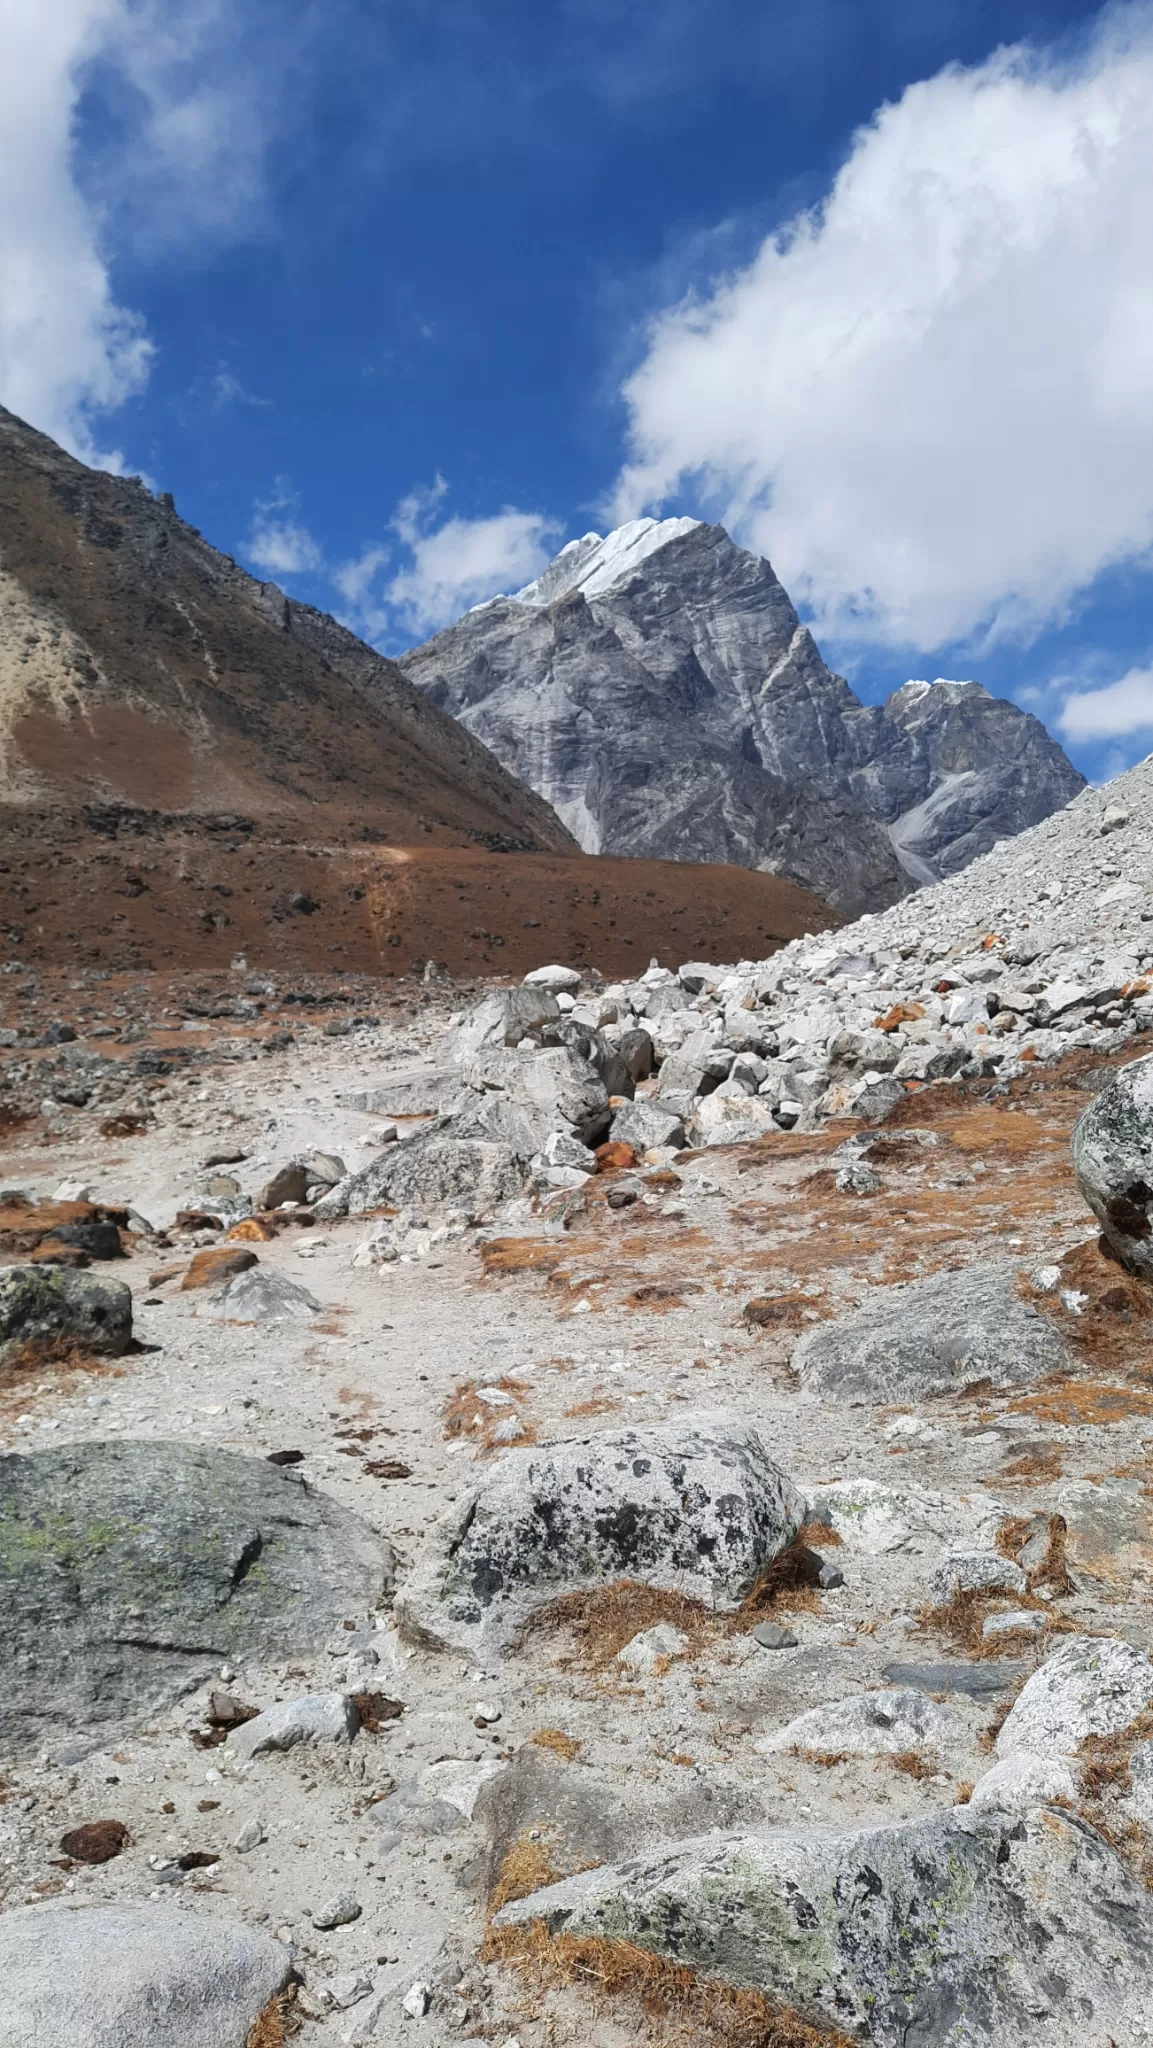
[385,477,559,633]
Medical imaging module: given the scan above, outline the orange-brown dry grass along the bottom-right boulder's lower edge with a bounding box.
[485,1921,852,2048]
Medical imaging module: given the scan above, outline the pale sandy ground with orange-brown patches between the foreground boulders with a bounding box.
[0,991,1153,2048]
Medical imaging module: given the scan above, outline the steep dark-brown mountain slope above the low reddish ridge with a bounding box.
[0,408,575,852]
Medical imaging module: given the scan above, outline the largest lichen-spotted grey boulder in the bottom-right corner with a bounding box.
[496,1806,1153,2048]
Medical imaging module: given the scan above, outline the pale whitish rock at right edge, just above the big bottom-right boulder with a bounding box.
[997,1636,1153,1757]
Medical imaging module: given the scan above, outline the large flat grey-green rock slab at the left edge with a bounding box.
[0,1444,393,1755]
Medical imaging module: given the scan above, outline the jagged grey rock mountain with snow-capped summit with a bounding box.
[401,518,1083,915]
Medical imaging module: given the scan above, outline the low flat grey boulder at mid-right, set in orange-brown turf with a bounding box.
[793,1264,1071,1401]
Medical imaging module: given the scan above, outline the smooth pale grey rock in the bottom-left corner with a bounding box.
[0,1905,293,2048]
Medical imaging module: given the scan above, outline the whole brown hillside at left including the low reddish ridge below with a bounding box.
[0,410,831,975]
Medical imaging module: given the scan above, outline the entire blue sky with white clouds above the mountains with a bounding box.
[0,0,1153,774]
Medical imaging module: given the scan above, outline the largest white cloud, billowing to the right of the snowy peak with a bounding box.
[616,4,1153,649]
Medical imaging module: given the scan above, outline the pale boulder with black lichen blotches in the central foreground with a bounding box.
[397,1413,805,1655]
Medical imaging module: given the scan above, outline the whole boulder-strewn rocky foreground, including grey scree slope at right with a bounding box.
[0,770,1153,2048]
